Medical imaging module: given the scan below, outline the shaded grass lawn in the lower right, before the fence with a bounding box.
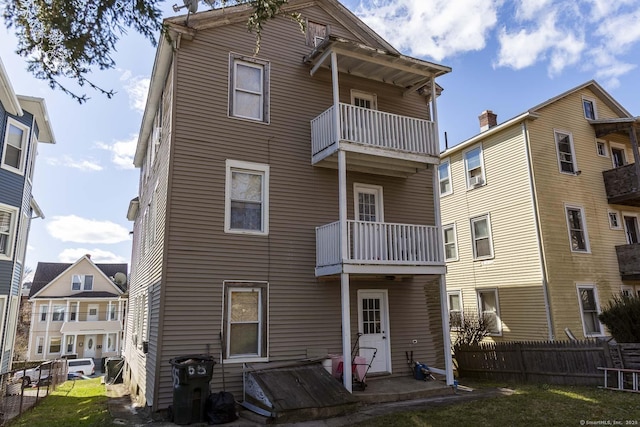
[357,383,640,427]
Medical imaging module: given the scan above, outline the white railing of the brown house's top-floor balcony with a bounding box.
[311,103,439,156]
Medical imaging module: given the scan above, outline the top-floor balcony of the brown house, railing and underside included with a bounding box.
[311,103,439,177]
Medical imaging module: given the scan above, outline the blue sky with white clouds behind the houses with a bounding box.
[0,0,640,280]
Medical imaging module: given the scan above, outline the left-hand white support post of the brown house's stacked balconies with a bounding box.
[331,52,353,393]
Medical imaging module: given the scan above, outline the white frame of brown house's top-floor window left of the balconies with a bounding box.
[228,52,270,124]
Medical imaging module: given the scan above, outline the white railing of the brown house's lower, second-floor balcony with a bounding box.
[316,220,444,267]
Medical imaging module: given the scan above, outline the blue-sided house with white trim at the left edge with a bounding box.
[0,56,55,373]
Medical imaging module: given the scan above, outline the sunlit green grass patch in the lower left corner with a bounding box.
[8,378,111,427]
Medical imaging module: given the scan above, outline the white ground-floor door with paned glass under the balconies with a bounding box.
[358,289,391,373]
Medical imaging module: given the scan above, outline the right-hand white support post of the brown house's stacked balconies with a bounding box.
[431,76,453,386]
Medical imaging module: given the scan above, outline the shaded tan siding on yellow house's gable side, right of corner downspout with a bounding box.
[530,88,640,339]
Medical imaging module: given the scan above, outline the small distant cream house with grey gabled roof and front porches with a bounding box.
[27,255,128,366]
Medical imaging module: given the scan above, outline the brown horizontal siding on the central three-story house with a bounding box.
[145,8,443,409]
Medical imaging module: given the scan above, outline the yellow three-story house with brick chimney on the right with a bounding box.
[440,81,640,341]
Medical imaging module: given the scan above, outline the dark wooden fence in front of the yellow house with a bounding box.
[455,340,611,385]
